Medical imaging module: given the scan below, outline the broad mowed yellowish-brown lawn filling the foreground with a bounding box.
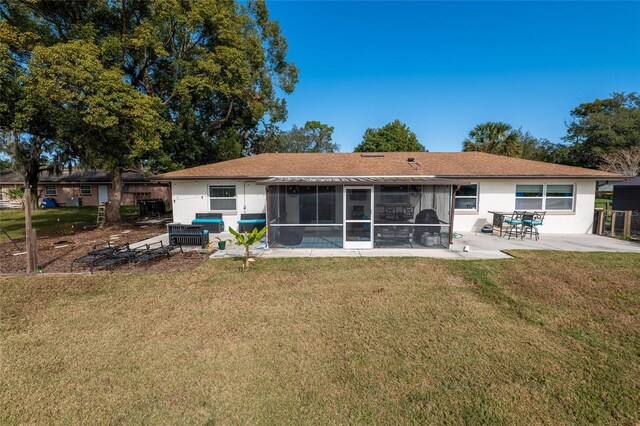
[0,252,640,425]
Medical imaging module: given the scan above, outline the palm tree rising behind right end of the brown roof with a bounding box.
[462,121,522,157]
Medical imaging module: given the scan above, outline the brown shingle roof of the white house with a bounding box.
[158,152,620,180]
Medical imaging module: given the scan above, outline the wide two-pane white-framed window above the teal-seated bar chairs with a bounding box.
[516,183,575,211]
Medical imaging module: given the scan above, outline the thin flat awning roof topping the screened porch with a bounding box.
[257,176,468,186]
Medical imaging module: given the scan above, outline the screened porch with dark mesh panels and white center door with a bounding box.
[261,177,458,249]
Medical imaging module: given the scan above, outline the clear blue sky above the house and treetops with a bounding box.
[268,1,640,152]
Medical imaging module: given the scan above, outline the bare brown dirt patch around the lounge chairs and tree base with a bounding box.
[0,224,206,274]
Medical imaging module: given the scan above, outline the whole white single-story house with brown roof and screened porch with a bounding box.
[158,152,621,248]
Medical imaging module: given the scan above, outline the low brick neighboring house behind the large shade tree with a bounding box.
[0,170,171,206]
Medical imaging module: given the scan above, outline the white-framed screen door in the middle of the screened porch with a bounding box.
[342,186,374,249]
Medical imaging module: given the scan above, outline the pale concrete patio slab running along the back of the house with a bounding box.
[132,233,640,259]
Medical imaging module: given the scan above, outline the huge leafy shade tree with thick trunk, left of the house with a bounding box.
[0,0,297,223]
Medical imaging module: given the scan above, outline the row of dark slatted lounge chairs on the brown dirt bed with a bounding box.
[71,241,182,272]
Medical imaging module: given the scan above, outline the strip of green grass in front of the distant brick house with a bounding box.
[0,206,139,242]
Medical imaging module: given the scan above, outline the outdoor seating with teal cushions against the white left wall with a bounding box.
[167,213,267,248]
